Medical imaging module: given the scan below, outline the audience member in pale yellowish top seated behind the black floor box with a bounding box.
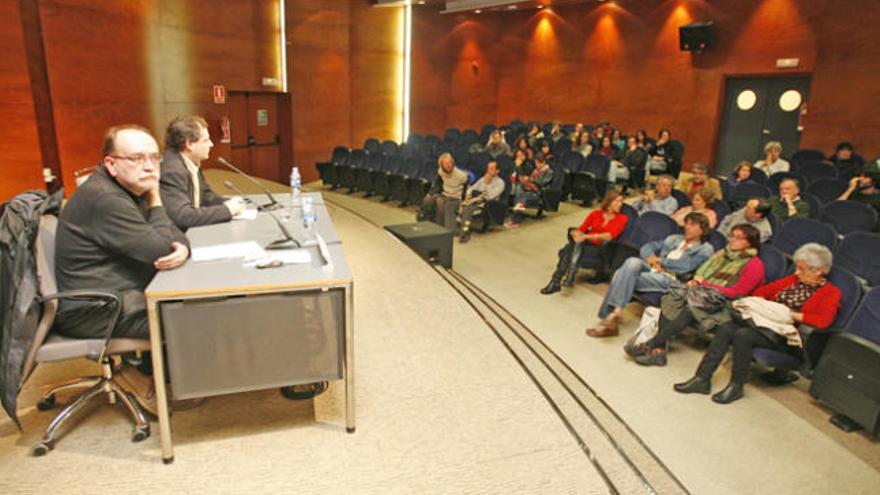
[417,153,468,229]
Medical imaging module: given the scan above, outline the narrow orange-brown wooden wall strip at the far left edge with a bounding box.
[0,1,44,202]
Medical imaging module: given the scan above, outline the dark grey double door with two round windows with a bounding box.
[715,76,810,175]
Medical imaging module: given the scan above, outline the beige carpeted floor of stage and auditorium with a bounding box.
[0,170,880,494]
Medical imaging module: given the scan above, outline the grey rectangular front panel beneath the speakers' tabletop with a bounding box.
[160,289,344,399]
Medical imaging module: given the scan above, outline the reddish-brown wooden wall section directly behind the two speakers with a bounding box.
[41,0,281,193]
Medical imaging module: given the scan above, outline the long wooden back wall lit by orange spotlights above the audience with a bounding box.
[413,0,880,168]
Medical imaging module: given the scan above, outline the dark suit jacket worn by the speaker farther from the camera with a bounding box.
[159,149,232,231]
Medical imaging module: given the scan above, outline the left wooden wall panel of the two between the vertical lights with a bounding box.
[286,0,353,181]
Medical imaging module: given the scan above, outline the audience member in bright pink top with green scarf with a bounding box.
[624,224,764,366]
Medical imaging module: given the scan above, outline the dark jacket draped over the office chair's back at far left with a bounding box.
[0,191,63,428]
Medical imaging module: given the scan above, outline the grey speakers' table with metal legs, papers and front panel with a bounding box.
[145,193,355,463]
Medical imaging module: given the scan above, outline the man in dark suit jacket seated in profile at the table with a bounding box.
[160,116,245,230]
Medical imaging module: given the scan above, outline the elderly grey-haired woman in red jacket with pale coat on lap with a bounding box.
[674,242,841,404]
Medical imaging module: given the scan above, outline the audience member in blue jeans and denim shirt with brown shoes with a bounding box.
[587,213,712,337]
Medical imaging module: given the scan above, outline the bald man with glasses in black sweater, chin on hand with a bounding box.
[55,125,189,414]
